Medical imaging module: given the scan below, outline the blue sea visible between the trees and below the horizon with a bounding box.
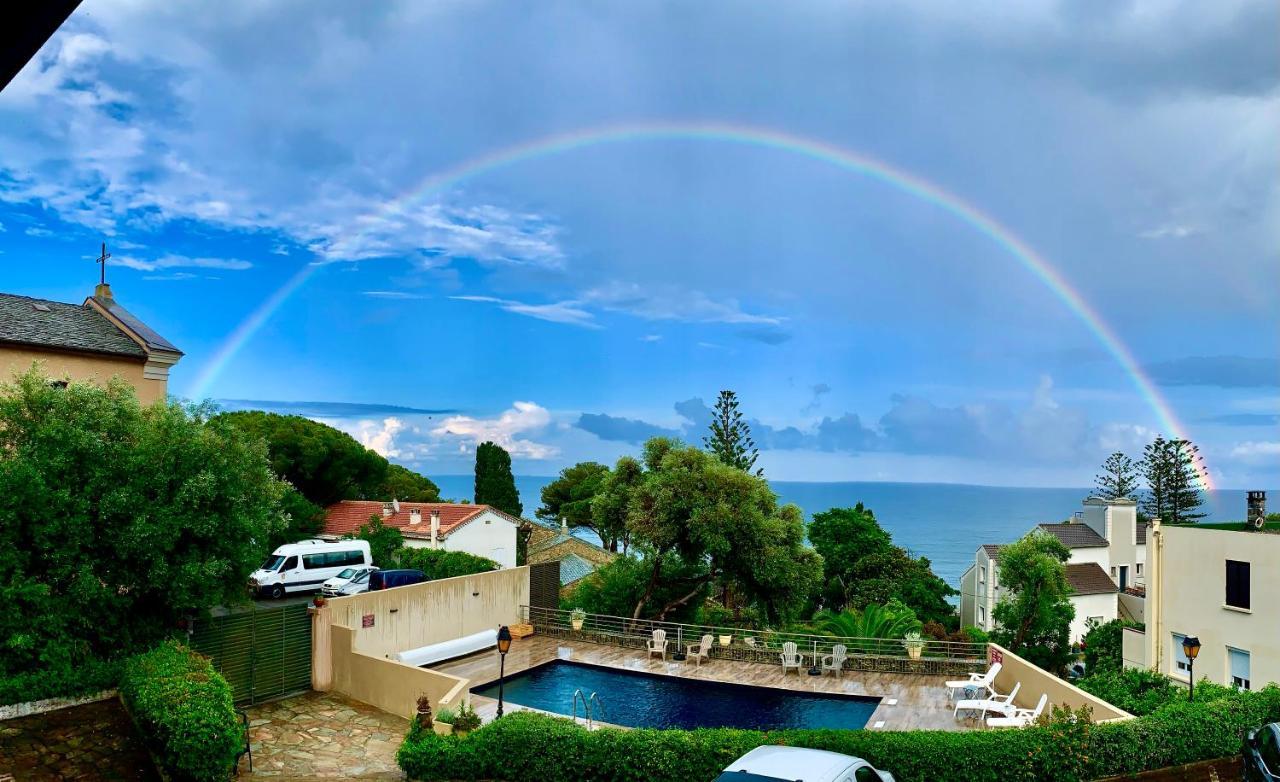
[431,475,1259,586]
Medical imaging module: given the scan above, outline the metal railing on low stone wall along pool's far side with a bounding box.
[521,605,987,674]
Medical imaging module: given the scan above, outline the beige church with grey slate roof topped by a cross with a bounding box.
[0,284,182,404]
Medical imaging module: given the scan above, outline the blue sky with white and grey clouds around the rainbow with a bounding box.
[0,0,1280,488]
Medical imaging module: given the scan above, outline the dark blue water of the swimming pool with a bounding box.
[471,660,879,730]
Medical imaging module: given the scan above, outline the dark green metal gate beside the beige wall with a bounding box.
[191,603,311,704]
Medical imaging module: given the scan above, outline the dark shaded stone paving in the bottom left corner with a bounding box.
[0,698,160,782]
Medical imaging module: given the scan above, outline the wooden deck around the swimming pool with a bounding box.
[433,635,977,731]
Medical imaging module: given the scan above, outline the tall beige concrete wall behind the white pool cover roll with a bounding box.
[329,567,529,657]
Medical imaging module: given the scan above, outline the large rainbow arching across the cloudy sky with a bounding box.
[192,122,1212,489]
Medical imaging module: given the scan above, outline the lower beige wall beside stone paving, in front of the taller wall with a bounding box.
[330,625,468,719]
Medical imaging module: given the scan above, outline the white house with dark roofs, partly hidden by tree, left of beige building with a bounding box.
[960,497,1147,644]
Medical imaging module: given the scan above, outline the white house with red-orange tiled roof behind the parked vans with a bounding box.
[320,499,521,567]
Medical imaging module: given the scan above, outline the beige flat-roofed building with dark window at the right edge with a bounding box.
[1124,525,1280,690]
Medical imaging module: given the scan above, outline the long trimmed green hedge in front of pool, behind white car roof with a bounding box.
[398,686,1280,782]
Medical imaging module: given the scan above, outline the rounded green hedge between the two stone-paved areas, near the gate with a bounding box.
[119,641,244,782]
